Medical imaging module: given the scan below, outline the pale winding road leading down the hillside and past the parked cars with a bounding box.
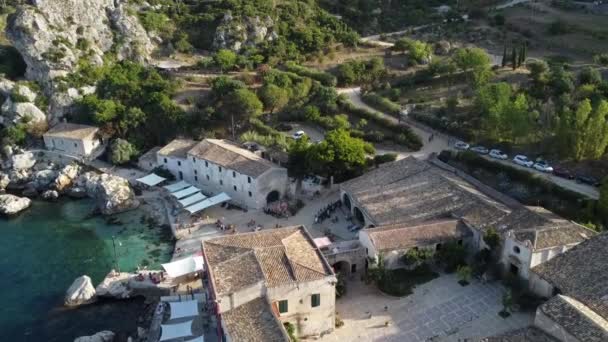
[338,88,599,199]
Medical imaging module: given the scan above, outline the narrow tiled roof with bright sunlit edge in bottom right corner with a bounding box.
[540,295,608,342]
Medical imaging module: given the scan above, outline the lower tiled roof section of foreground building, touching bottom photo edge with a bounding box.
[222,297,289,342]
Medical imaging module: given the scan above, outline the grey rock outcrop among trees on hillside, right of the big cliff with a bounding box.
[213,13,277,51]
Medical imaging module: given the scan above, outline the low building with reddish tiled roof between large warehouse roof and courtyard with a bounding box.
[359,219,473,269]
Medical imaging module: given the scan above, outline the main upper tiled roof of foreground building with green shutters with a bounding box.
[203,226,333,294]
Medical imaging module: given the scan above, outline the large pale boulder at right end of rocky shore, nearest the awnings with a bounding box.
[78,172,139,215]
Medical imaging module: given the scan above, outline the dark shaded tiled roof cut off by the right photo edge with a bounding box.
[532,233,608,319]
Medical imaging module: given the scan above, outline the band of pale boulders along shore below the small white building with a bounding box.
[0,147,139,216]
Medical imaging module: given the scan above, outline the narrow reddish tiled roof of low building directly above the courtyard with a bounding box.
[365,220,472,251]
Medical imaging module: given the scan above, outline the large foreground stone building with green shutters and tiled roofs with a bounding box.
[202,226,337,342]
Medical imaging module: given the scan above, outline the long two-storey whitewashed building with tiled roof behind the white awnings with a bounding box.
[157,139,289,209]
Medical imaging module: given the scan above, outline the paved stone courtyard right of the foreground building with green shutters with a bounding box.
[320,275,534,342]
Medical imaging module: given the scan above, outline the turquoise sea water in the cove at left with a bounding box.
[0,199,173,342]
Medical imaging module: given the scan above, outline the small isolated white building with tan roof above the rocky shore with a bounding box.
[43,122,102,157]
